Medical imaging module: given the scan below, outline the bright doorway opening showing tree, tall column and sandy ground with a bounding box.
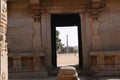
[56,26,79,67]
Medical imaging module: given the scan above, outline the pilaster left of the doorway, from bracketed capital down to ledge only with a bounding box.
[29,0,43,52]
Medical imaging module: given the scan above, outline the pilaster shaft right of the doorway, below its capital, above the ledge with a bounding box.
[90,16,102,51]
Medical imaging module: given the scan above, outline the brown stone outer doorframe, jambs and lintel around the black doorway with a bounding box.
[41,7,90,72]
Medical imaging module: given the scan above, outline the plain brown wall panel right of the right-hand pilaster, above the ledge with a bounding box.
[100,0,120,51]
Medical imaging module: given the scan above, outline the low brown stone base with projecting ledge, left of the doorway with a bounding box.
[8,53,48,78]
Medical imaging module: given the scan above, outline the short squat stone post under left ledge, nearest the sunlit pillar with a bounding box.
[13,56,22,70]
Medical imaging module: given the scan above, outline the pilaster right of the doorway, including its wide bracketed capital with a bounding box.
[87,0,105,51]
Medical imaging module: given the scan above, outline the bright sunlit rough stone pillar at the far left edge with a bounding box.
[0,0,8,80]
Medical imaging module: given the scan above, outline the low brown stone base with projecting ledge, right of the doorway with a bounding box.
[90,51,120,76]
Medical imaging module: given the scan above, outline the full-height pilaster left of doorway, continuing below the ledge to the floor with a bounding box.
[30,0,48,77]
